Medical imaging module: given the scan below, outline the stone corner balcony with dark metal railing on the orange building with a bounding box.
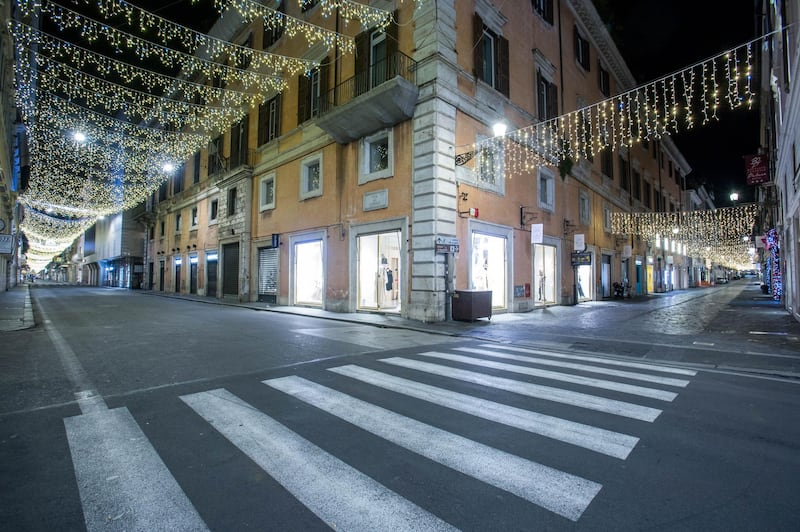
[317,52,419,144]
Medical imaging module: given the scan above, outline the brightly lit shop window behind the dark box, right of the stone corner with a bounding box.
[470,232,508,308]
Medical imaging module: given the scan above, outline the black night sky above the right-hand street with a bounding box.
[595,0,759,207]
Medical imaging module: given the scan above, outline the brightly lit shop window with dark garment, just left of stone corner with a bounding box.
[357,231,402,312]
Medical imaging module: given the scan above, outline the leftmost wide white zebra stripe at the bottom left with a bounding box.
[64,408,208,532]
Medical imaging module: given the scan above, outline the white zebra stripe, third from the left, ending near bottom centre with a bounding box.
[264,376,602,521]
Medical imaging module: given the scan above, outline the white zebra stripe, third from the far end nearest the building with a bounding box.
[418,351,678,401]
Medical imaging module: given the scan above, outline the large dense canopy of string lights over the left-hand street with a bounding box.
[8,0,392,266]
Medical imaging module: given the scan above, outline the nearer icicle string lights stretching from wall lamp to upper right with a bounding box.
[456,39,760,179]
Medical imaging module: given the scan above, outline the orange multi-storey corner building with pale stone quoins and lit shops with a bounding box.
[146,0,689,322]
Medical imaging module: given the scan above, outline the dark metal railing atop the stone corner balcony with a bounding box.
[319,52,417,116]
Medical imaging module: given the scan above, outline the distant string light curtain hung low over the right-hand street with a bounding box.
[611,203,759,270]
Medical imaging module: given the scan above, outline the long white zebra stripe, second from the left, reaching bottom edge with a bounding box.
[181,389,456,530]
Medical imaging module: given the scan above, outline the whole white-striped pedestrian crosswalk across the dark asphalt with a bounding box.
[65,343,696,530]
